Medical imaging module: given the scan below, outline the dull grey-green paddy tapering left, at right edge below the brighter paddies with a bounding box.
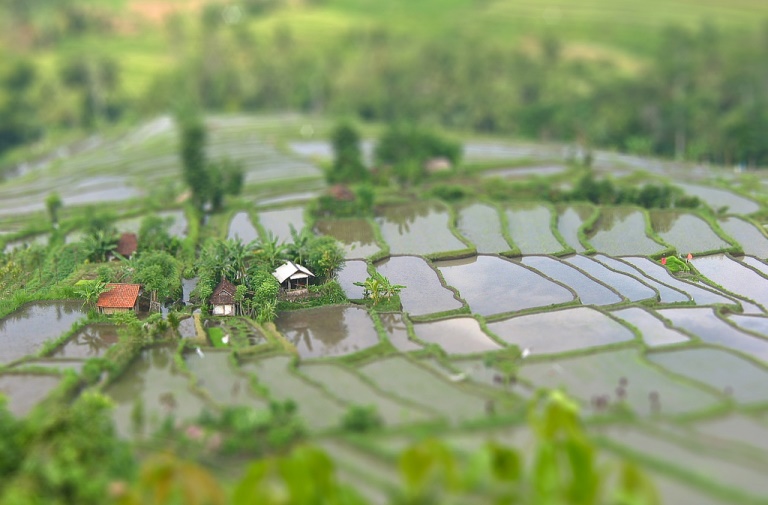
[648,349,768,404]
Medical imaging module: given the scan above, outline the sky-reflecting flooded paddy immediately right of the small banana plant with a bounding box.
[376,256,463,316]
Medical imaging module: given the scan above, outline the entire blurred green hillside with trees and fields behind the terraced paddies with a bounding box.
[0,0,768,167]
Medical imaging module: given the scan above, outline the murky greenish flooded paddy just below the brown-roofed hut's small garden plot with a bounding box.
[184,350,267,408]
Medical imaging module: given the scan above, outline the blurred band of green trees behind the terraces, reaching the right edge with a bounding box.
[147,15,768,164]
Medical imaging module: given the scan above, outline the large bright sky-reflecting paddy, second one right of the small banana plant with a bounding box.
[436,256,575,316]
